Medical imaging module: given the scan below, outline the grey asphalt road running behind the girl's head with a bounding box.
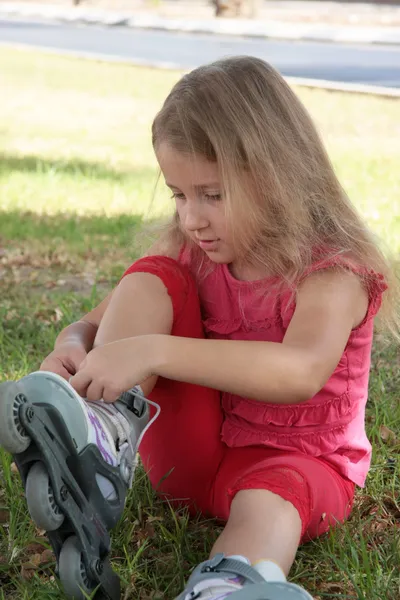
[0,19,400,88]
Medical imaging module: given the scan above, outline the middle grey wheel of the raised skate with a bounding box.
[26,462,65,531]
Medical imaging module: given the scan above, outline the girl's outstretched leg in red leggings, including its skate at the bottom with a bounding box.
[173,447,354,600]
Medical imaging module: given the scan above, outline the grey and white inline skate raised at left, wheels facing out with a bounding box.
[0,371,159,600]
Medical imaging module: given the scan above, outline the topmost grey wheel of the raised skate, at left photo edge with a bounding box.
[0,381,31,454]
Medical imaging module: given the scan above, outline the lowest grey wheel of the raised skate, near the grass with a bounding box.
[58,535,96,600]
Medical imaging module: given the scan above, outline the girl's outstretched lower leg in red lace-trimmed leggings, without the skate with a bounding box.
[212,448,354,574]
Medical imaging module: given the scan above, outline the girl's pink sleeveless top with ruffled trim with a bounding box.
[179,250,387,487]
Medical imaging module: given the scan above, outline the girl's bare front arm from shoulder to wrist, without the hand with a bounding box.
[154,270,368,404]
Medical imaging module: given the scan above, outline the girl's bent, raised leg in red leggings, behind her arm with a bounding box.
[96,256,224,512]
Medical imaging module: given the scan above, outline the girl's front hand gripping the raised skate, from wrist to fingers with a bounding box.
[70,335,156,402]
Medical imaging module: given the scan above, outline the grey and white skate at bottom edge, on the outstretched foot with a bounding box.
[176,554,312,600]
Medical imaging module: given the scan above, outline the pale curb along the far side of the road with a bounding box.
[0,3,400,45]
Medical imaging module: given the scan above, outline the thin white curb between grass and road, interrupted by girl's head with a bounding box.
[0,41,400,99]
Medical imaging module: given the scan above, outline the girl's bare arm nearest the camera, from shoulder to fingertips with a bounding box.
[72,270,368,404]
